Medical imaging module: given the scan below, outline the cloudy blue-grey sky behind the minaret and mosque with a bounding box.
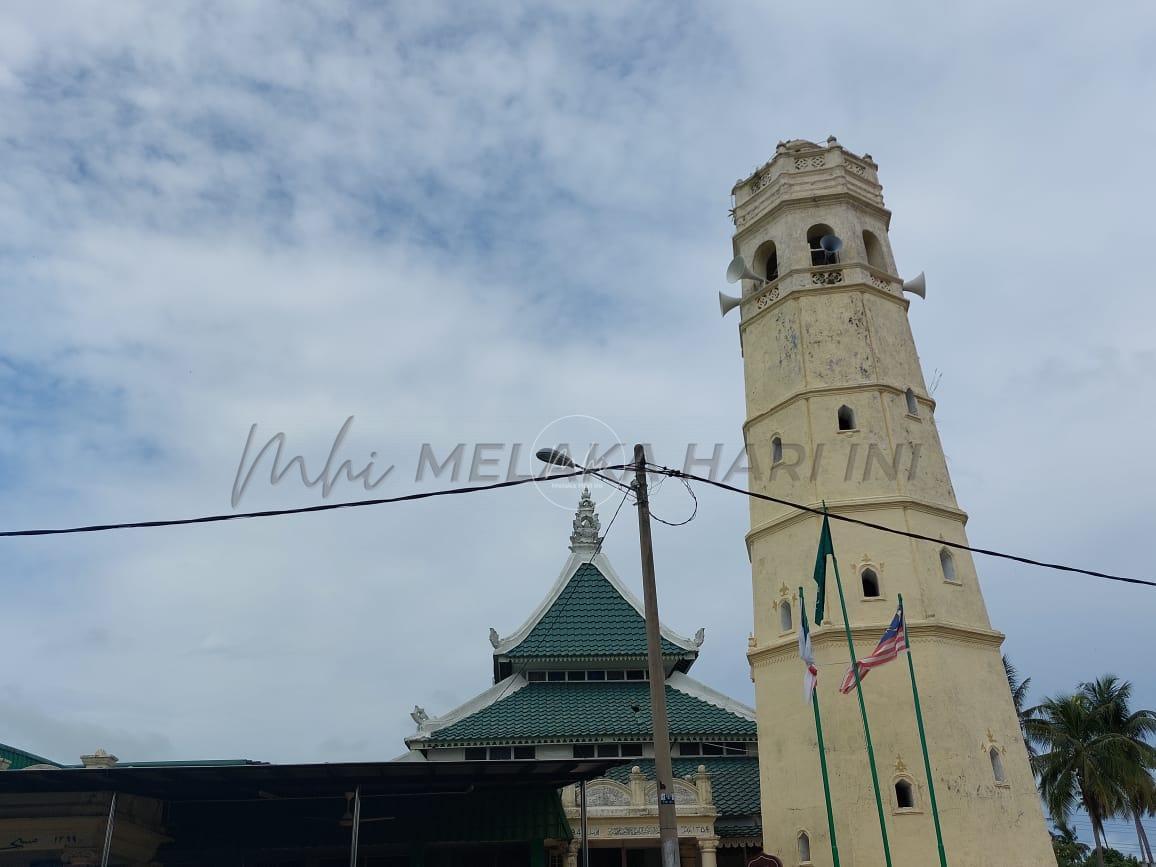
[0,0,1156,855]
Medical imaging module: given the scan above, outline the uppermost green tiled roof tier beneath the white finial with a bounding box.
[504,563,694,659]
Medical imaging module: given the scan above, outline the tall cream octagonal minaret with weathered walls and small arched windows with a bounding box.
[734,136,1055,867]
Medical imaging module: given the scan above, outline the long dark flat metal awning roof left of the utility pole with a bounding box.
[0,758,622,802]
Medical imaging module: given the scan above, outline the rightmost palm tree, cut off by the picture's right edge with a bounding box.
[1080,675,1156,864]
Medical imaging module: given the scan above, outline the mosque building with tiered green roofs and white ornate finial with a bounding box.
[406,491,762,867]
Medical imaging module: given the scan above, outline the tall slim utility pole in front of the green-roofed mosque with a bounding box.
[633,445,680,867]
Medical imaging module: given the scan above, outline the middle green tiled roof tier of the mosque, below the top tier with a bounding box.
[423,681,755,744]
